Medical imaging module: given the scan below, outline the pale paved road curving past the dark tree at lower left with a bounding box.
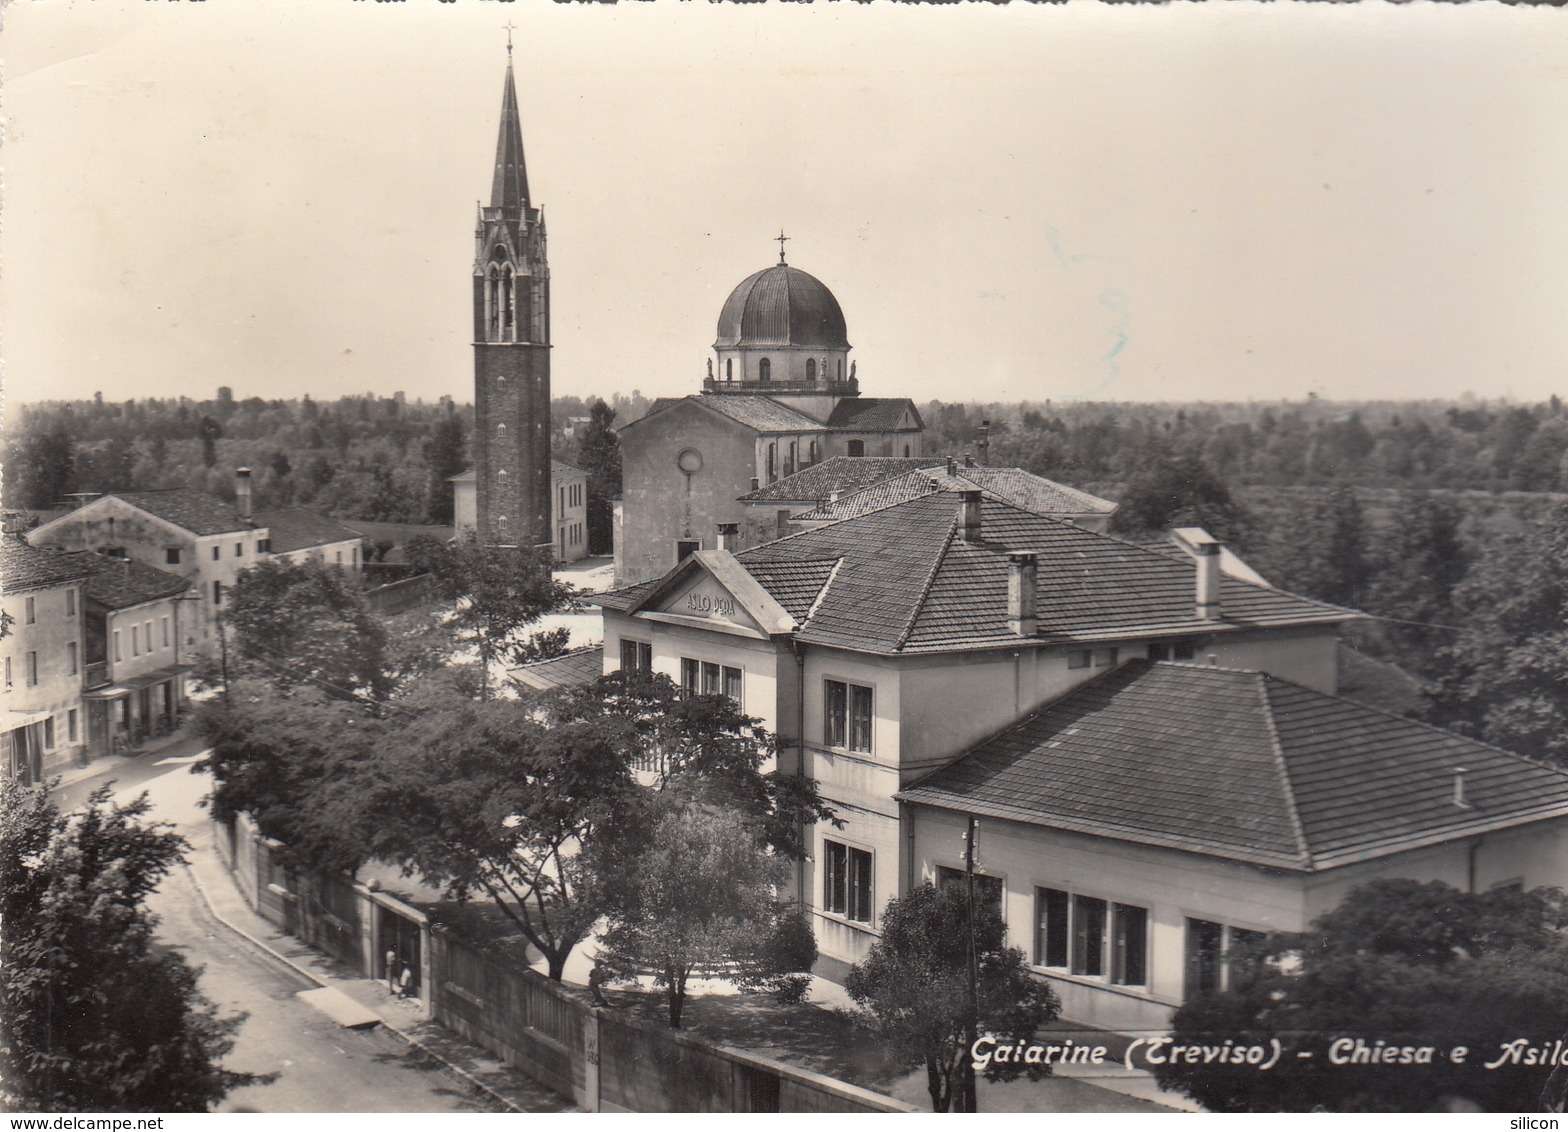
[56,743,494,1112]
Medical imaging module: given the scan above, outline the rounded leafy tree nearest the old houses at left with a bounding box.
[224,558,394,701]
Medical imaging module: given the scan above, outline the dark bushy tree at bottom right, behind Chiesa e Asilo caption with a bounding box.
[1156,880,1568,1112]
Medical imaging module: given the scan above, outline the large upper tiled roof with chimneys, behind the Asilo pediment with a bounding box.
[593,489,1359,655]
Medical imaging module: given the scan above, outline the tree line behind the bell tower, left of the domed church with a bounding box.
[5,387,633,553]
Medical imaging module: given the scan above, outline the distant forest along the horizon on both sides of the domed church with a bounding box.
[5,389,1568,760]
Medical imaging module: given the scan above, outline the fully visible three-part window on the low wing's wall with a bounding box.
[1035,889,1149,986]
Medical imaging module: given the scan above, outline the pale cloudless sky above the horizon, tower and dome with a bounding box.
[0,0,1568,401]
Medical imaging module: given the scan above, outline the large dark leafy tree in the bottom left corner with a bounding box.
[0,781,268,1112]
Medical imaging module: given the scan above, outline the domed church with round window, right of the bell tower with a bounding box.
[615,252,925,585]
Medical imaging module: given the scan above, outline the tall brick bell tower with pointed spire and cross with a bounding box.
[474,46,552,546]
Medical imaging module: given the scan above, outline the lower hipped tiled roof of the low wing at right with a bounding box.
[898,660,1568,870]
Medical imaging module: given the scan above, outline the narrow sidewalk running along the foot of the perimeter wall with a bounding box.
[187,825,577,1112]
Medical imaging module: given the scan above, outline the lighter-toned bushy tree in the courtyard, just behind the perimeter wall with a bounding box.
[601,798,817,1029]
